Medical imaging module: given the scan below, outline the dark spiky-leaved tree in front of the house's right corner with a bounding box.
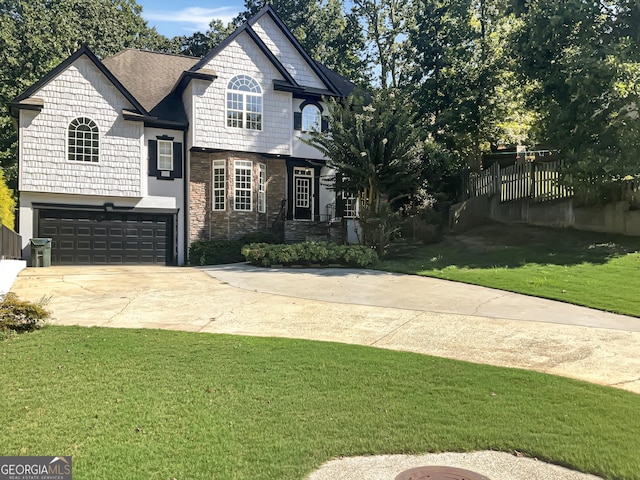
[307,91,422,248]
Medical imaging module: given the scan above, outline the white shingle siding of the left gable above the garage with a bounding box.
[20,57,143,197]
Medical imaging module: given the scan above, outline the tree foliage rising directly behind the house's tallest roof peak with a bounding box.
[234,0,367,84]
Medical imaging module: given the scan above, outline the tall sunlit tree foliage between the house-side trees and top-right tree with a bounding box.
[407,0,535,168]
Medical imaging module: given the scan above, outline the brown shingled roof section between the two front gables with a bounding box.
[103,49,198,124]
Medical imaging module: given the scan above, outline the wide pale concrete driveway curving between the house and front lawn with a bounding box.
[11,265,640,393]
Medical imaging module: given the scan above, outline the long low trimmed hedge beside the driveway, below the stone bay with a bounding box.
[242,242,378,268]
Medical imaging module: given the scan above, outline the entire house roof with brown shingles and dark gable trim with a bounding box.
[9,5,355,128]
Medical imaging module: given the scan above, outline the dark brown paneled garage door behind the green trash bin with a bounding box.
[38,210,173,265]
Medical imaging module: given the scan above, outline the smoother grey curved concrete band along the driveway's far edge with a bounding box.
[200,263,640,332]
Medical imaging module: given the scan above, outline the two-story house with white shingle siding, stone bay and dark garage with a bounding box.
[10,6,354,265]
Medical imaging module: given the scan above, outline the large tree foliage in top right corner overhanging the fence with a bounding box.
[514,0,640,189]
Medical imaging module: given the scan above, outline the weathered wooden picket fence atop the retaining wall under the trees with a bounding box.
[463,162,573,202]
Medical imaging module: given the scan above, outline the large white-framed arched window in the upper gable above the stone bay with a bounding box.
[227,75,262,130]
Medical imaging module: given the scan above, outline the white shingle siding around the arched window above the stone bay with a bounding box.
[192,33,293,155]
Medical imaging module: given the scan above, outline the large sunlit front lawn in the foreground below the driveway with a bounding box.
[0,327,640,480]
